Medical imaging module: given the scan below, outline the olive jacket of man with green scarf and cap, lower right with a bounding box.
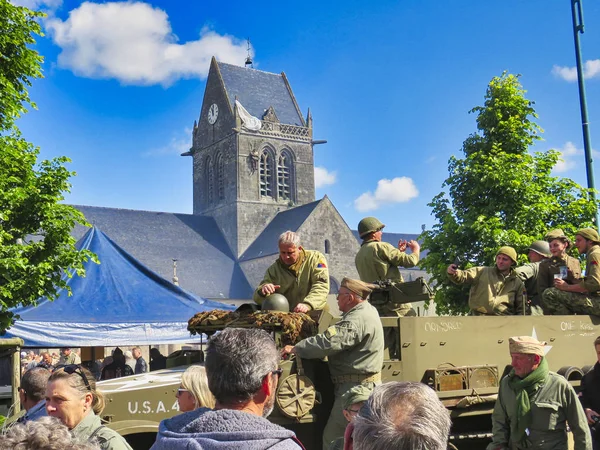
[487,372,592,450]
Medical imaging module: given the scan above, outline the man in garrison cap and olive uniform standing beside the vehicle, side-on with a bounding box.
[281,278,383,449]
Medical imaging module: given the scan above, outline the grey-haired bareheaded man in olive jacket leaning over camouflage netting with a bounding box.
[254,231,329,313]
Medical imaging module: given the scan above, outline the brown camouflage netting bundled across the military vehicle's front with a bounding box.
[188,309,317,345]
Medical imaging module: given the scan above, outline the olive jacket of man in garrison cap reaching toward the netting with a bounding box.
[295,302,383,377]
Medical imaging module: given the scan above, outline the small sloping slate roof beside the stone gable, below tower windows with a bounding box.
[240,200,322,262]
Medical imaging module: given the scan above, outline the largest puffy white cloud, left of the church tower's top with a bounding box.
[46,2,247,85]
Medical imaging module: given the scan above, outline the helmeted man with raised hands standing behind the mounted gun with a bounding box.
[354,217,420,358]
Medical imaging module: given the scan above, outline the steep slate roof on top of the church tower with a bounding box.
[217,62,304,126]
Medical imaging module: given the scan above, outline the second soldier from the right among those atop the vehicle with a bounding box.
[538,228,581,302]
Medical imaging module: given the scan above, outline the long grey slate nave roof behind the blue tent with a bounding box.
[73,205,252,299]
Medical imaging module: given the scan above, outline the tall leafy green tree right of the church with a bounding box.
[422,72,597,314]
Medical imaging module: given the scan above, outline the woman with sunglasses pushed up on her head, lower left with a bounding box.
[46,364,131,450]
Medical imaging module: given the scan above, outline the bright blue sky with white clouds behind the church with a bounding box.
[13,0,600,233]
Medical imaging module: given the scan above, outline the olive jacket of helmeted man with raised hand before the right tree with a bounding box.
[448,266,524,316]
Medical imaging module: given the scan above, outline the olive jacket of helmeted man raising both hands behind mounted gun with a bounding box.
[354,240,420,314]
